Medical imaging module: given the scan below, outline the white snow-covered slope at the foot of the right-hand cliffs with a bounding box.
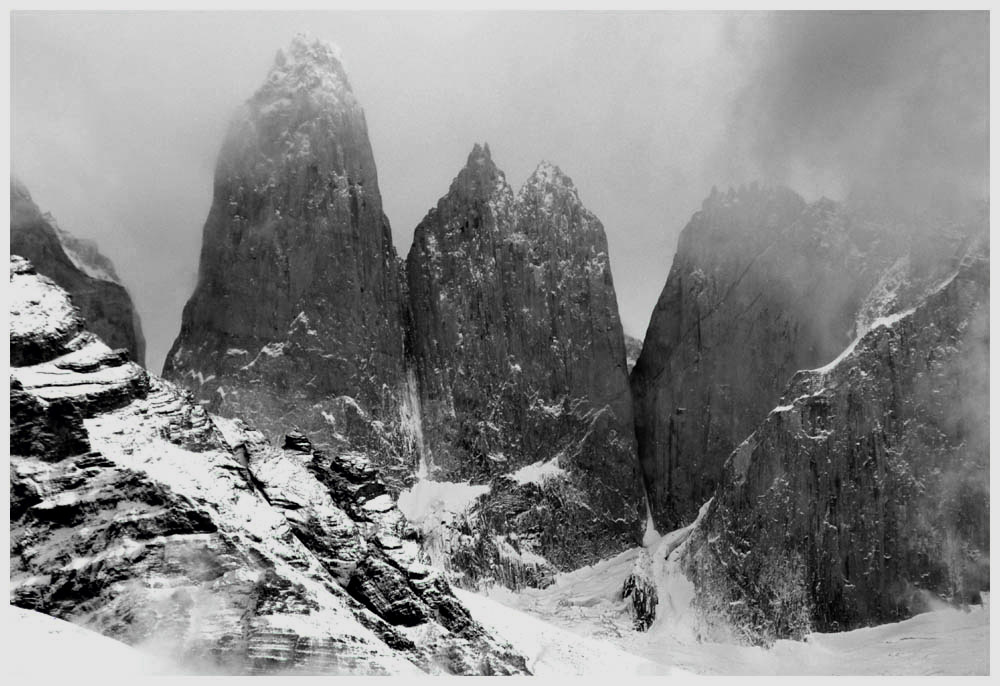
[457,528,989,676]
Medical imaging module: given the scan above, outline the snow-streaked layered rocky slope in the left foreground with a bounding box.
[10,257,526,674]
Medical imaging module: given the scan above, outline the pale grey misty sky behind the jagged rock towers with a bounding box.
[11,12,988,371]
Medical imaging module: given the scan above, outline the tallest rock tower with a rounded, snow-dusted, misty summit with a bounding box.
[164,37,412,467]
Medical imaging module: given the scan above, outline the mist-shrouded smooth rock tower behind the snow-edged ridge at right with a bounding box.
[631,186,975,531]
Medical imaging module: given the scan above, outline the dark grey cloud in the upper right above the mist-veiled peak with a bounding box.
[724,12,989,216]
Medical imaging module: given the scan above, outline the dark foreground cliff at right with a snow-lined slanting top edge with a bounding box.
[687,253,989,643]
